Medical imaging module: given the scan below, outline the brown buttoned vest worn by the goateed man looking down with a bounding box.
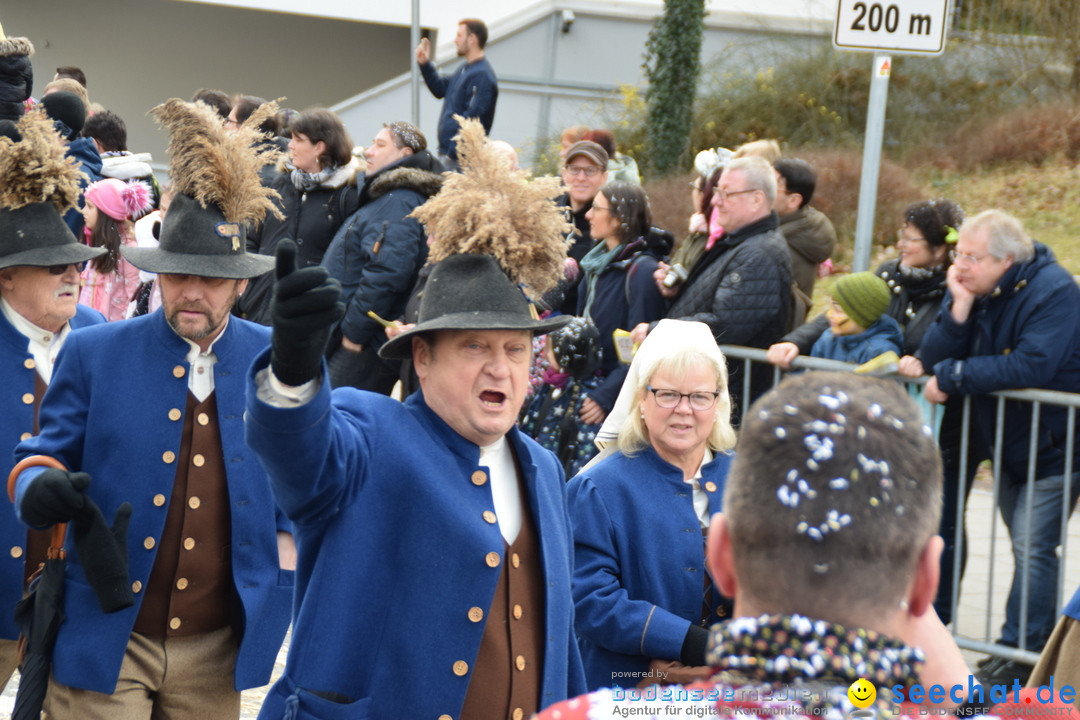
[135,393,233,637]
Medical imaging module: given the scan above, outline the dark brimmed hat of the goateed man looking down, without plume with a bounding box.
[120,194,274,279]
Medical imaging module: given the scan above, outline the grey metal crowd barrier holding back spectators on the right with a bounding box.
[720,345,1080,664]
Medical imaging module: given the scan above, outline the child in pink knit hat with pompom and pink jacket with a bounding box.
[79,178,152,322]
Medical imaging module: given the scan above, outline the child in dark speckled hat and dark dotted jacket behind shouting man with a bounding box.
[521,317,600,479]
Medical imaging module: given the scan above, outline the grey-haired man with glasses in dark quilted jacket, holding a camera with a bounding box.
[633,158,792,418]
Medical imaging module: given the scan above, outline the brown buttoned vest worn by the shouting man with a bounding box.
[461,463,545,720]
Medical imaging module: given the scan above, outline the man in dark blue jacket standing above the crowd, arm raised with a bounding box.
[416,18,499,169]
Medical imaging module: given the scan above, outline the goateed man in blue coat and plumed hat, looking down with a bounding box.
[15,100,293,720]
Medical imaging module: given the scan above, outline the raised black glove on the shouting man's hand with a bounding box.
[270,240,345,386]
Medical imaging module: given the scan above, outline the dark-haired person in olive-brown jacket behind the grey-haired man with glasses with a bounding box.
[772,158,836,298]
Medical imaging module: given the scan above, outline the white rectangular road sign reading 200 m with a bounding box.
[833,0,948,55]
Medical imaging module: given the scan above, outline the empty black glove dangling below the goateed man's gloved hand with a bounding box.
[71,498,135,613]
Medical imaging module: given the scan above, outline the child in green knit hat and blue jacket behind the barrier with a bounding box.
[810,272,904,365]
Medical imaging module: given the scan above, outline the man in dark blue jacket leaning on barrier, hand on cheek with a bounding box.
[920,210,1080,683]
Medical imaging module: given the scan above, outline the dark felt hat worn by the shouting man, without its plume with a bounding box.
[379,254,570,359]
